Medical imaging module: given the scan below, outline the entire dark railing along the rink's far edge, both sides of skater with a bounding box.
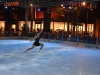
[0,31,100,47]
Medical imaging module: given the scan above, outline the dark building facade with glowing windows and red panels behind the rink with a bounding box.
[0,1,100,36]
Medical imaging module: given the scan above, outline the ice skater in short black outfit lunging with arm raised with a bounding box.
[25,31,44,52]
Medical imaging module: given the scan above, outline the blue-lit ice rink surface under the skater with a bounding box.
[0,40,100,75]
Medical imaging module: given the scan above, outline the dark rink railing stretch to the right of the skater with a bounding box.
[43,33,100,46]
